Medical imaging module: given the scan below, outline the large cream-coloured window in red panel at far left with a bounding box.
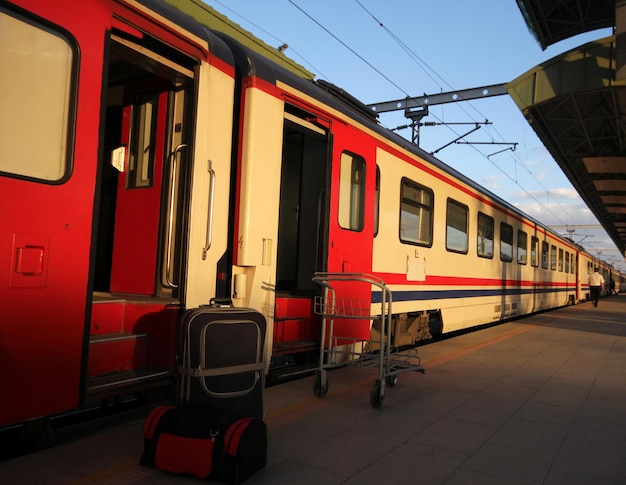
[0,10,75,182]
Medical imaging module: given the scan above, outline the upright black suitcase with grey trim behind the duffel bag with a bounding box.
[179,307,266,419]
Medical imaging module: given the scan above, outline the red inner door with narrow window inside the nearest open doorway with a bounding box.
[109,79,185,295]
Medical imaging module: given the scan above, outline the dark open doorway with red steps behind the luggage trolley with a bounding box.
[273,111,330,362]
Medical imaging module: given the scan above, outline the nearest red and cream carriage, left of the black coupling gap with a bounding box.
[0,0,235,426]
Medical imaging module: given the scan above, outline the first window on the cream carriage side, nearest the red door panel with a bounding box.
[400,178,434,246]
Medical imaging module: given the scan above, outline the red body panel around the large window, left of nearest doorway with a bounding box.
[0,0,111,425]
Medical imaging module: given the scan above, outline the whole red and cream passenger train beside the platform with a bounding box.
[0,0,625,427]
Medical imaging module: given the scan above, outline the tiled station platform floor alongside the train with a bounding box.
[0,294,626,485]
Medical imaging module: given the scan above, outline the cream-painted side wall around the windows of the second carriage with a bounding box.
[373,145,573,330]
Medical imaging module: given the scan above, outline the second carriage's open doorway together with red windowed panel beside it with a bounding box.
[273,106,375,360]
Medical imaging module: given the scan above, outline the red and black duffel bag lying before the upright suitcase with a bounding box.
[141,405,267,483]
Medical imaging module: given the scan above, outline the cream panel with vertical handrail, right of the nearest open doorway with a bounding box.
[185,63,234,308]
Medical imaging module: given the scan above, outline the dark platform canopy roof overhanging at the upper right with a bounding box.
[506,0,626,254]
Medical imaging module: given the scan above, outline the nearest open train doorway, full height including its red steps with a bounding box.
[85,31,194,398]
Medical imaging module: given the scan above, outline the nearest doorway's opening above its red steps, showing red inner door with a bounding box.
[95,37,192,296]
